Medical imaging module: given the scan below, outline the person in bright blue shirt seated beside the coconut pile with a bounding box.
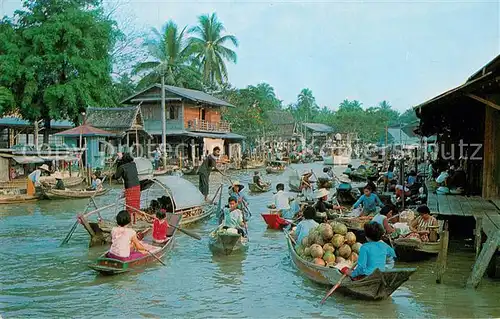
[341,222,396,278]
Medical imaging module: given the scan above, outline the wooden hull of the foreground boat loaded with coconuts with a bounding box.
[286,236,416,300]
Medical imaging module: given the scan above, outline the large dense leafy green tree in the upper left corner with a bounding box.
[0,0,116,143]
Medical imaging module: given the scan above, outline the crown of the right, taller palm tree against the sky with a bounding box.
[189,13,238,85]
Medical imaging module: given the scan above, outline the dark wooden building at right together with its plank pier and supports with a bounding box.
[415,55,500,287]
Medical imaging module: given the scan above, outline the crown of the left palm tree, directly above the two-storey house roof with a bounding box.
[133,20,201,88]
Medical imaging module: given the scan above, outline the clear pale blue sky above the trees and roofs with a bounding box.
[0,0,500,111]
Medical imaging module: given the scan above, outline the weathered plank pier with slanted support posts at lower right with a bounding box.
[427,188,500,288]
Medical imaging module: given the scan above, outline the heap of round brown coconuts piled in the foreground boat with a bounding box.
[297,222,361,267]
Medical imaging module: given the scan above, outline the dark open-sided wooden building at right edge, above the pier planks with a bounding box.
[415,55,500,198]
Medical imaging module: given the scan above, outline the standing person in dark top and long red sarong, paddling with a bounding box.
[114,153,141,224]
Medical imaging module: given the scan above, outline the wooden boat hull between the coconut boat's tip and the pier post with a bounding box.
[392,238,441,262]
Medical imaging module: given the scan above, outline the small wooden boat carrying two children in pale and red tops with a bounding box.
[88,214,182,275]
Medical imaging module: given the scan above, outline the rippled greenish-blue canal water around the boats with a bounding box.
[0,163,500,318]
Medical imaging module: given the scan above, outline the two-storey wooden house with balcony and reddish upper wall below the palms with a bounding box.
[122,84,245,165]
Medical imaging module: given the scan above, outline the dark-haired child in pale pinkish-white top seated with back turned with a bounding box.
[107,210,147,260]
